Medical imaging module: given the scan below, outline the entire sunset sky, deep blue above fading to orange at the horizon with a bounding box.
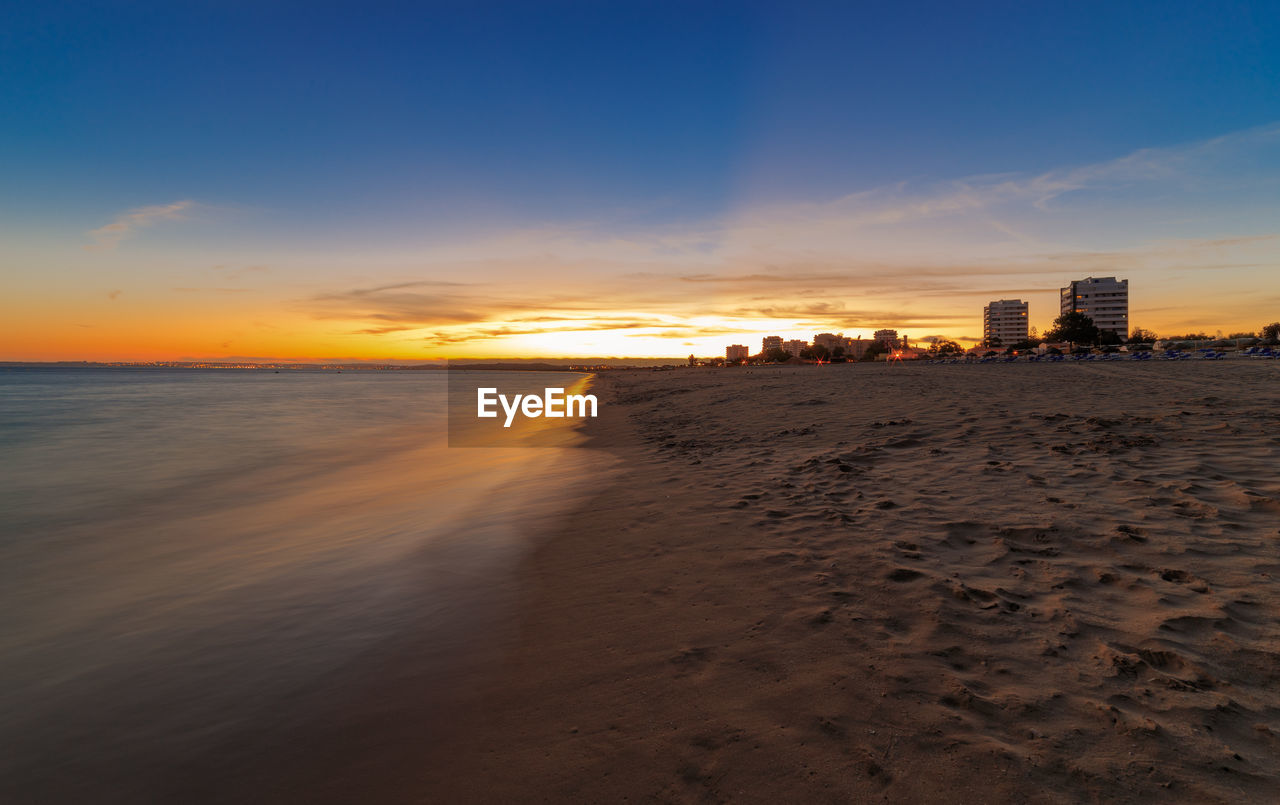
[0,0,1280,361]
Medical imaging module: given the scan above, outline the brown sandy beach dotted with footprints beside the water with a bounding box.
[422,361,1280,802]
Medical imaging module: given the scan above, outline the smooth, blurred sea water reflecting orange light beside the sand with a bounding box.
[0,370,604,801]
